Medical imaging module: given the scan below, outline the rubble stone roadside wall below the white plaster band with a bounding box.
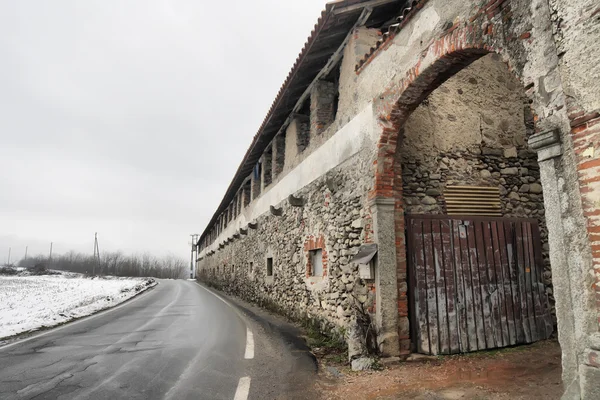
[198,152,374,353]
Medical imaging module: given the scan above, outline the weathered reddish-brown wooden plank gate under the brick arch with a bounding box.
[407,215,553,354]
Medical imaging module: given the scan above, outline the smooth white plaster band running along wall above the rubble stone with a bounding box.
[200,103,376,257]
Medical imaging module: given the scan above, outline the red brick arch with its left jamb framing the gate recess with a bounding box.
[369,25,535,353]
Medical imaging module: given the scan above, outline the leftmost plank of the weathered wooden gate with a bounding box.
[412,219,431,354]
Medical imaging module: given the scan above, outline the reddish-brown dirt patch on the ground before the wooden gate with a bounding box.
[317,340,562,400]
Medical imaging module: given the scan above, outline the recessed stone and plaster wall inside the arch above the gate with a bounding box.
[399,55,554,320]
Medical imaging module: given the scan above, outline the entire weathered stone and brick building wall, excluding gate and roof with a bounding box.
[199,0,600,398]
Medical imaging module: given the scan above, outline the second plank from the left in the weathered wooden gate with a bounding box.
[423,220,440,355]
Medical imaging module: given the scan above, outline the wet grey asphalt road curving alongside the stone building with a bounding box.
[0,281,316,400]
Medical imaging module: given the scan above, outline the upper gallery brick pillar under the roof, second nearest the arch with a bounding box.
[310,81,337,136]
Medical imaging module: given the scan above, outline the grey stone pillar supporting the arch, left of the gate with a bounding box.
[369,197,400,357]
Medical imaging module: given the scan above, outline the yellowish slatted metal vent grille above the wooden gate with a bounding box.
[444,186,502,217]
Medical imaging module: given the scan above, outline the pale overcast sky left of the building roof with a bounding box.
[0,0,325,262]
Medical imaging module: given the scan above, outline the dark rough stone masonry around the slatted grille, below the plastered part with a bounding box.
[402,147,555,314]
